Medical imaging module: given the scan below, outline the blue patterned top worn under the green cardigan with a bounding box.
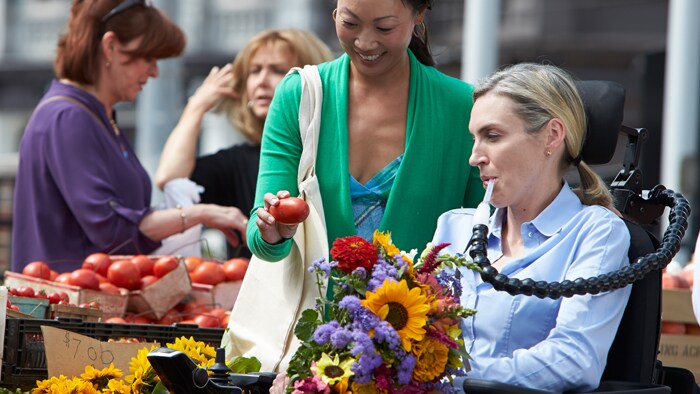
[350,155,403,242]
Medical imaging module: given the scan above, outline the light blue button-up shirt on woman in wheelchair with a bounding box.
[433,183,631,392]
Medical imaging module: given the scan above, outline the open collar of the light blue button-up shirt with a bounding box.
[489,181,583,239]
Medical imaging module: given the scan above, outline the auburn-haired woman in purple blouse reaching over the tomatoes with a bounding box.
[12,0,247,272]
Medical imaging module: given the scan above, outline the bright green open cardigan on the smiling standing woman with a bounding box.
[247,50,484,261]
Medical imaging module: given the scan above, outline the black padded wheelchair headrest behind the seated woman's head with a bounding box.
[576,81,625,164]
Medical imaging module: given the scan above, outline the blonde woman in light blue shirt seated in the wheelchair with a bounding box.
[433,64,631,392]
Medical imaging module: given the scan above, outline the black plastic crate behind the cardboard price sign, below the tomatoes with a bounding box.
[2,318,224,389]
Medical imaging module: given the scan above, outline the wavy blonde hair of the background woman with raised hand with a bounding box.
[217,29,332,145]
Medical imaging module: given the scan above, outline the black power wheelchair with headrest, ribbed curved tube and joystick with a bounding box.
[148,81,700,394]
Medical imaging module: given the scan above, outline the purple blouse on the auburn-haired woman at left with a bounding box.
[12,81,160,272]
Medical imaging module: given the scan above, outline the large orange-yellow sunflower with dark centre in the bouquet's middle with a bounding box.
[362,279,430,351]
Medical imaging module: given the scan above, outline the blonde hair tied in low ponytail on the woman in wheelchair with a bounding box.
[474,63,616,211]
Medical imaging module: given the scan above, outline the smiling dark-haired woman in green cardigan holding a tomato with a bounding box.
[247,0,484,261]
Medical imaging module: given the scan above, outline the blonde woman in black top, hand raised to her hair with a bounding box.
[155,29,331,257]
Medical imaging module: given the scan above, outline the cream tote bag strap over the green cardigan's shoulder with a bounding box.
[290,65,323,184]
